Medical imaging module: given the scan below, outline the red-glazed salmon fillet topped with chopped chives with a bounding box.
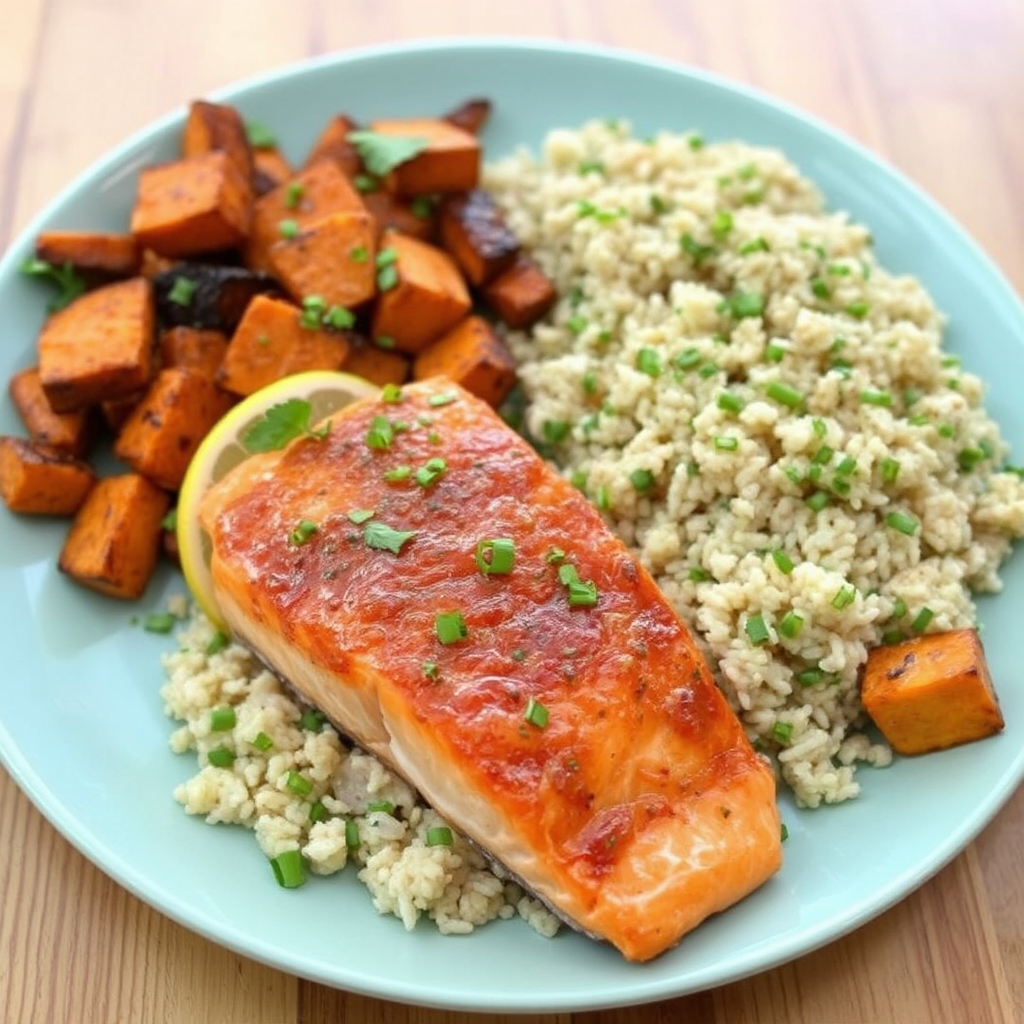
[200,379,781,961]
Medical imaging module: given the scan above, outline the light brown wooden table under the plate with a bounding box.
[0,0,1024,1024]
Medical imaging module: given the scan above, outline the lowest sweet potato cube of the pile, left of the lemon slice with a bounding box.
[57,473,171,600]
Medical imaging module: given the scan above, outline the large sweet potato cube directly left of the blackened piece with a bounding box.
[39,278,154,413]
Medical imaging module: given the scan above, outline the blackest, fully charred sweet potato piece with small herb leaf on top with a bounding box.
[153,262,281,334]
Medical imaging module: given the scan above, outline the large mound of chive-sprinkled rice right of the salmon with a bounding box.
[484,122,1024,807]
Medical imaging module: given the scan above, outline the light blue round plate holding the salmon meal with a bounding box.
[0,41,1024,1011]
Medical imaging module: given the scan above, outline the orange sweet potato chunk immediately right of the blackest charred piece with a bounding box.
[270,205,377,308]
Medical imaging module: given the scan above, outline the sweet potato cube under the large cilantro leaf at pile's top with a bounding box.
[370,118,481,196]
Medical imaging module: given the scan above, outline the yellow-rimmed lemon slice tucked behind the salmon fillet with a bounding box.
[176,370,380,628]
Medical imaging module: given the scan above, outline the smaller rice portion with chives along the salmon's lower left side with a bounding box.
[160,601,559,936]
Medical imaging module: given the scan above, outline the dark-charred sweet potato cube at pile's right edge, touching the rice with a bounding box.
[438,188,519,288]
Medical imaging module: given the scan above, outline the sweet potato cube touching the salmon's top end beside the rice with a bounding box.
[413,315,515,408]
